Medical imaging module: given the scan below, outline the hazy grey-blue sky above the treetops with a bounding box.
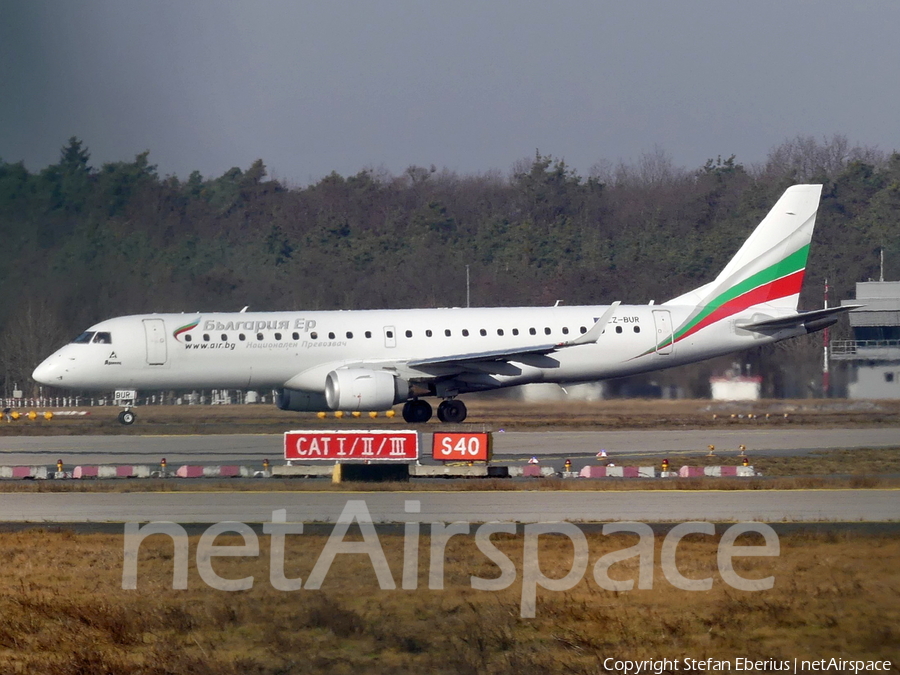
[0,0,900,185]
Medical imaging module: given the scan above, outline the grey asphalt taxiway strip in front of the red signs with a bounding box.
[0,489,900,523]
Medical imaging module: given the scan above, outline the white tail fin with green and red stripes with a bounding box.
[665,185,822,339]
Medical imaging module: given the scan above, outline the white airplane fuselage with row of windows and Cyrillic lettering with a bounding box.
[34,305,805,392]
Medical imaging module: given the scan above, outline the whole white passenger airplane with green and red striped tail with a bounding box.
[33,185,859,424]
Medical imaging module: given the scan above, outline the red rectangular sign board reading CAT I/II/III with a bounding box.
[284,431,419,462]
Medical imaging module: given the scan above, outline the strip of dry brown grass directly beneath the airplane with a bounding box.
[0,398,900,436]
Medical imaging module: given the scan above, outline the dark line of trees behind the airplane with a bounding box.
[0,136,900,393]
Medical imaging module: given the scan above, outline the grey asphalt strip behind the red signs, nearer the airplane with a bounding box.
[0,425,900,466]
